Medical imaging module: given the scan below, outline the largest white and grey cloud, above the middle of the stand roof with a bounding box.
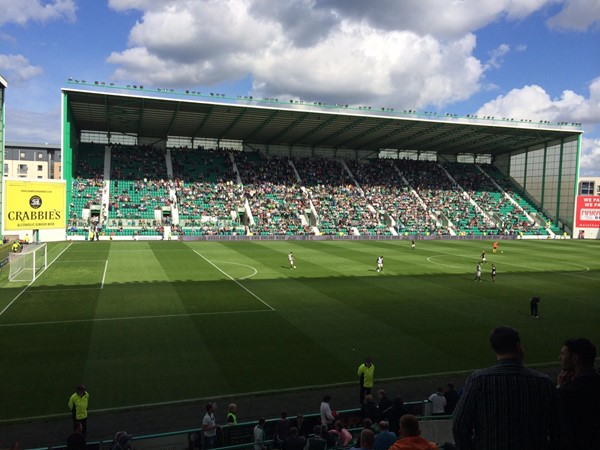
[107,0,597,108]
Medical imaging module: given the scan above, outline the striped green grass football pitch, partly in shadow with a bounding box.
[0,240,600,421]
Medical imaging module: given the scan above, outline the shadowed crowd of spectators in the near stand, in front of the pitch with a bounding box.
[13,326,600,450]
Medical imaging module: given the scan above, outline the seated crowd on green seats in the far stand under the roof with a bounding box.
[69,145,560,239]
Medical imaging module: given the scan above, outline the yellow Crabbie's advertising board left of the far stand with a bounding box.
[2,179,66,231]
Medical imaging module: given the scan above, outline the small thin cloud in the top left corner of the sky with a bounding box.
[0,0,77,25]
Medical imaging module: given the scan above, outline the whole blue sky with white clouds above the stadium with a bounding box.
[0,0,600,176]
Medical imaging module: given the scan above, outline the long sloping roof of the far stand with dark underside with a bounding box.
[62,87,582,155]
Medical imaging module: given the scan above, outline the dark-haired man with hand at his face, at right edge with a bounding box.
[557,338,600,450]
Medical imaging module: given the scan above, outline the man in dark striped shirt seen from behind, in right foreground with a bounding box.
[452,326,560,450]
